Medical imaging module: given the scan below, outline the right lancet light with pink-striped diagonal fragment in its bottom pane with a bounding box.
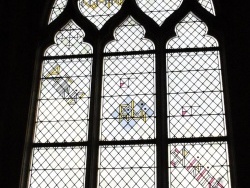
[166,13,230,188]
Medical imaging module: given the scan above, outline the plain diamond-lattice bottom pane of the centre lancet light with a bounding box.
[98,145,156,188]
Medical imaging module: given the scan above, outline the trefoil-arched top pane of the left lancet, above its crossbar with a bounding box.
[45,20,92,56]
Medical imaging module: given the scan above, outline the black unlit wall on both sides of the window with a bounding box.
[0,0,250,188]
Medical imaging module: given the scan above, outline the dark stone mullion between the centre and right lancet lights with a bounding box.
[155,35,168,188]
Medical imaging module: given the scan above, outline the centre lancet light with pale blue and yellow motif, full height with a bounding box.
[98,16,156,188]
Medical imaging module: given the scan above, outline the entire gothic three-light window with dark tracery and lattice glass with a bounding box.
[22,0,233,188]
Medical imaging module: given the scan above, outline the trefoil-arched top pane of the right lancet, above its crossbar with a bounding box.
[167,12,218,49]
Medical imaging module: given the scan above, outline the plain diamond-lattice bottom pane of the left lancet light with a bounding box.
[30,147,86,188]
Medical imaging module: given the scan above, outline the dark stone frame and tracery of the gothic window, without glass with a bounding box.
[20,0,236,188]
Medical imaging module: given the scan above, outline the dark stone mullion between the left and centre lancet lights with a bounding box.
[85,42,103,188]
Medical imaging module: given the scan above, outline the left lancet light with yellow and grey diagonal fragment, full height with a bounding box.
[30,21,92,188]
